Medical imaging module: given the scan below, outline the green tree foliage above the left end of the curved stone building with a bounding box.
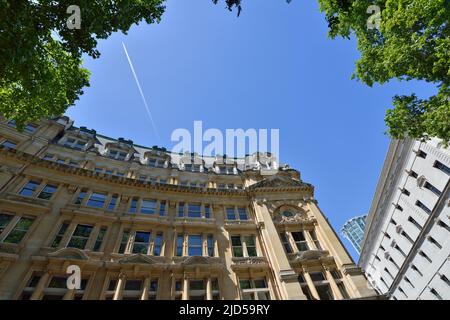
[0,0,165,128]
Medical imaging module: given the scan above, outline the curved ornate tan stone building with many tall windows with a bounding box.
[0,117,377,300]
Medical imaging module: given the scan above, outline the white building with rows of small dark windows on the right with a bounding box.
[359,139,450,300]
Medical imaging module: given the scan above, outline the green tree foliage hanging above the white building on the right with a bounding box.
[319,0,450,143]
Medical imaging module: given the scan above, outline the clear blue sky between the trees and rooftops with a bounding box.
[67,0,433,257]
